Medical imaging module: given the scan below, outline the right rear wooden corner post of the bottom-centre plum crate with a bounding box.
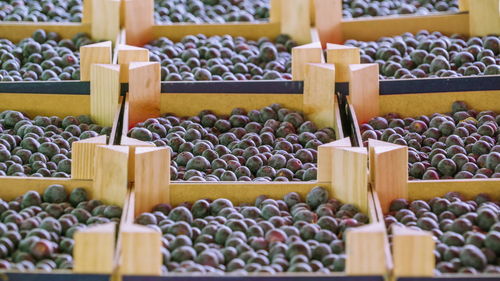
[332,147,368,213]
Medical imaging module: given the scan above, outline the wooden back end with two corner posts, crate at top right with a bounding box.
[315,0,500,43]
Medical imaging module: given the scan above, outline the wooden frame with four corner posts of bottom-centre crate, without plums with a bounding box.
[114,141,390,280]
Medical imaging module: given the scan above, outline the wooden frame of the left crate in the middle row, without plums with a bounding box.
[0,75,121,179]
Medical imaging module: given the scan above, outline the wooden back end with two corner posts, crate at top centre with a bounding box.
[122,0,314,46]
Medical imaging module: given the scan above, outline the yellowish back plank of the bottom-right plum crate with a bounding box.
[408,179,500,200]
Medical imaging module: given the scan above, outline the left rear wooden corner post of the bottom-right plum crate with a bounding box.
[368,139,408,213]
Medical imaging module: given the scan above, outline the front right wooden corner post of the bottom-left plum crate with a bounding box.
[73,223,116,274]
